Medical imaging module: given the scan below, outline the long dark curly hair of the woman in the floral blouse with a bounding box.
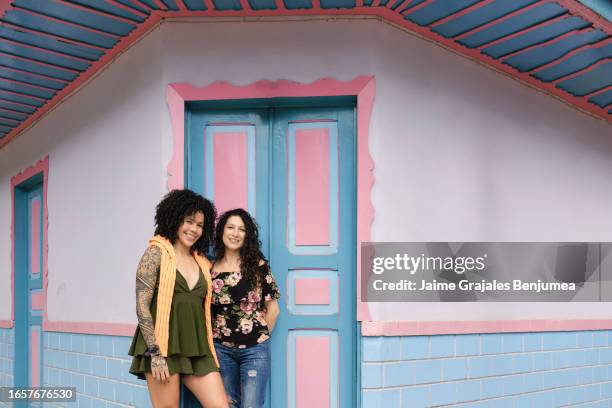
[214,208,267,288]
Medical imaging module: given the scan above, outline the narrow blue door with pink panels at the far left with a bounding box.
[14,183,44,404]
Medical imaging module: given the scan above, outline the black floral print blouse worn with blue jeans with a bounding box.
[212,264,280,348]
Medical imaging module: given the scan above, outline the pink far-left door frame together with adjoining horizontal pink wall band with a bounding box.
[0,156,136,336]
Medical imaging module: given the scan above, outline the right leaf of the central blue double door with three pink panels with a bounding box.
[270,107,356,408]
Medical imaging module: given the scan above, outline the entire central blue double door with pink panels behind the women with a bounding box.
[186,101,357,408]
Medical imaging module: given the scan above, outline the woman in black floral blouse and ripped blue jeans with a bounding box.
[212,208,280,408]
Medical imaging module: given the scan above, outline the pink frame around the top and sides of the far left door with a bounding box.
[10,156,49,328]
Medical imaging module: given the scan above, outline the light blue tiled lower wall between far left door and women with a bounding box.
[43,332,151,408]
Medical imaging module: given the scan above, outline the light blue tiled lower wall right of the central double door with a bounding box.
[361,331,612,408]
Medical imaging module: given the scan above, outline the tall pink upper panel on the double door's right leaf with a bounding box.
[295,129,330,245]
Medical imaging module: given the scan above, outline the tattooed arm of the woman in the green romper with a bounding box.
[136,246,161,347]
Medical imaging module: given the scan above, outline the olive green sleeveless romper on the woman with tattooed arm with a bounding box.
[128,271,219,380]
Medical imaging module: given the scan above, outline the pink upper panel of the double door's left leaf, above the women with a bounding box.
[213,132,249,214]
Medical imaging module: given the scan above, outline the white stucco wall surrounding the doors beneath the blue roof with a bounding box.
[0,20,612,322]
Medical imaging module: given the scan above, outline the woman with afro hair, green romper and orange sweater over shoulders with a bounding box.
[129,190,228,408]
